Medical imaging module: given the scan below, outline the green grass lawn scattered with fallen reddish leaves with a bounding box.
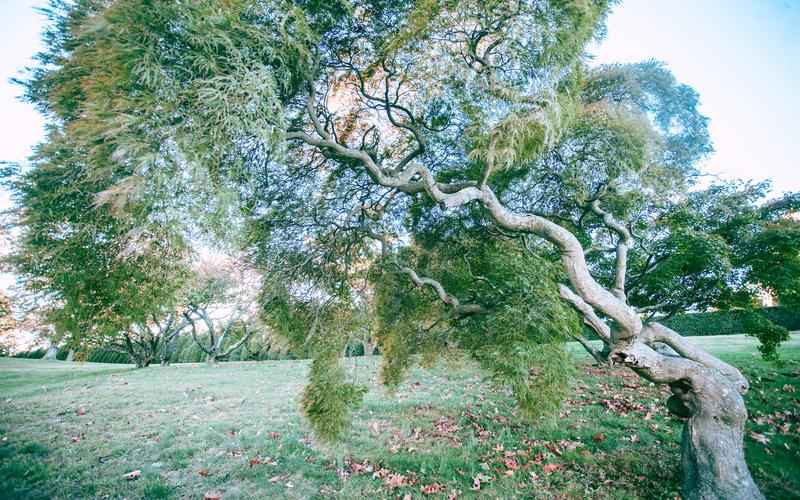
[0,334,800,499]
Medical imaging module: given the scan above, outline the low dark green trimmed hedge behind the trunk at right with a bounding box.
[663,307,800,337]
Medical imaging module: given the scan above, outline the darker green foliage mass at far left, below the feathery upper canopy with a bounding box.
[3,133,190,352]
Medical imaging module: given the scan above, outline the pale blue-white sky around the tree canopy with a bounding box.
[0,0,800,288]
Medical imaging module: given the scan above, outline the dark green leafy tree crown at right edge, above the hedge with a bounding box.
[620,183,800,333]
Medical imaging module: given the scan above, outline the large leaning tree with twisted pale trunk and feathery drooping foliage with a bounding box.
[14,0,796,498]
